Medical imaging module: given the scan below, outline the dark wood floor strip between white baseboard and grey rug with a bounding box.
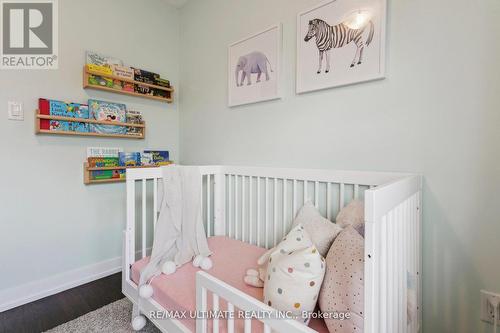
[0,273,124,333]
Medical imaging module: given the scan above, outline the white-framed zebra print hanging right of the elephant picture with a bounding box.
[296,0,386,93]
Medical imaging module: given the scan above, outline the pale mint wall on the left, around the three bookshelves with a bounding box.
[0,0,179,288]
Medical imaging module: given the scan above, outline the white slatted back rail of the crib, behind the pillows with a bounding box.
[217,166,404,248]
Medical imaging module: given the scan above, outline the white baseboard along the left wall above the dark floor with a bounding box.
[0,248,151,312]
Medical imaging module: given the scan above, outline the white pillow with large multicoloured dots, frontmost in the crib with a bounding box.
[264,224,326,324]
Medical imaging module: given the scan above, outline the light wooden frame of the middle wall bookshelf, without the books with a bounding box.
[35,110,146,139]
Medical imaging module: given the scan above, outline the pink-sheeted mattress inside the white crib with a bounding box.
[131,236,328,332]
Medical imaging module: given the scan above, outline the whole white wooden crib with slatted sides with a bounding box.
[122,166,422,333]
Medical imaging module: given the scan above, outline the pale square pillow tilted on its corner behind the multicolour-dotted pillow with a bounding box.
[293,201,342,257]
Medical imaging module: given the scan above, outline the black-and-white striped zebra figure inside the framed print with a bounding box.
[304,19,374,74]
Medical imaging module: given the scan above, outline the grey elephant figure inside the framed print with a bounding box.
[234,51,273,87]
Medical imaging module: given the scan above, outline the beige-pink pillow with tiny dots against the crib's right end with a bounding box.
[319,226,364,333]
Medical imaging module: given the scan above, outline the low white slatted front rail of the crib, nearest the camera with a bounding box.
[196,272,315,333]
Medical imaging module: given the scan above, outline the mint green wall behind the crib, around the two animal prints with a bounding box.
[180,0,500,333]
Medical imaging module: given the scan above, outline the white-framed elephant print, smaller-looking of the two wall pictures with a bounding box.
[228,25,282,106]
